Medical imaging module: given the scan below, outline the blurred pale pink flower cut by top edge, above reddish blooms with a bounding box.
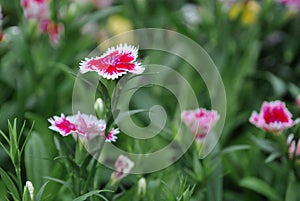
[21,0,50,20]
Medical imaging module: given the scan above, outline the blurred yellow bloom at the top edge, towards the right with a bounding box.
[229,0,260,24]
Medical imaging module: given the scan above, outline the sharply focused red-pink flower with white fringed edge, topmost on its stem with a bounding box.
[79,44,144,80]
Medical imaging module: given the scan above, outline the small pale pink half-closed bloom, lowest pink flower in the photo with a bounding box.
[111,155,134,182]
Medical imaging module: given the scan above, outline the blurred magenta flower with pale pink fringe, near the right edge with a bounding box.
[249,101,300,133]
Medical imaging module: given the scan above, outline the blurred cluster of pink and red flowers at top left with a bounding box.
[21,0,63,45]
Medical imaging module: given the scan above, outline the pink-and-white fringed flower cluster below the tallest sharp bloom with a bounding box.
[48,112,120,142]
